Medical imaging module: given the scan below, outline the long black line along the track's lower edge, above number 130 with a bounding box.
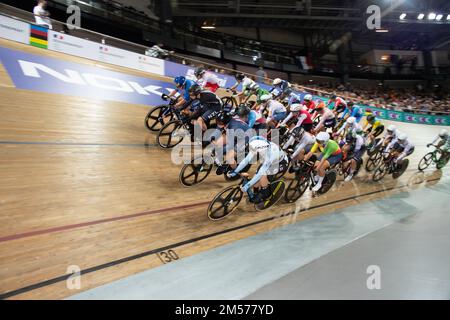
[0,178,441,300]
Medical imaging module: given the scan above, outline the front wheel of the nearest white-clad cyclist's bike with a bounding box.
[207,185,244,221]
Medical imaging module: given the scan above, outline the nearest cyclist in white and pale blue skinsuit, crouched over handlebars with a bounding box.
[228,136,288,203]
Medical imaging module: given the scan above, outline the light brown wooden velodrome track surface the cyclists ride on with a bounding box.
[0,40,446,299]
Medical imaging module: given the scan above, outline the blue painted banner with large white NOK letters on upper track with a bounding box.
[0,48,173,106]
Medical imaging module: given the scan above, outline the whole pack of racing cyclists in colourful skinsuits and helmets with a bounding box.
[154,67,450,212]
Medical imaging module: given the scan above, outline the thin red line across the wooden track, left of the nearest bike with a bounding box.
[0,201,209,242]
